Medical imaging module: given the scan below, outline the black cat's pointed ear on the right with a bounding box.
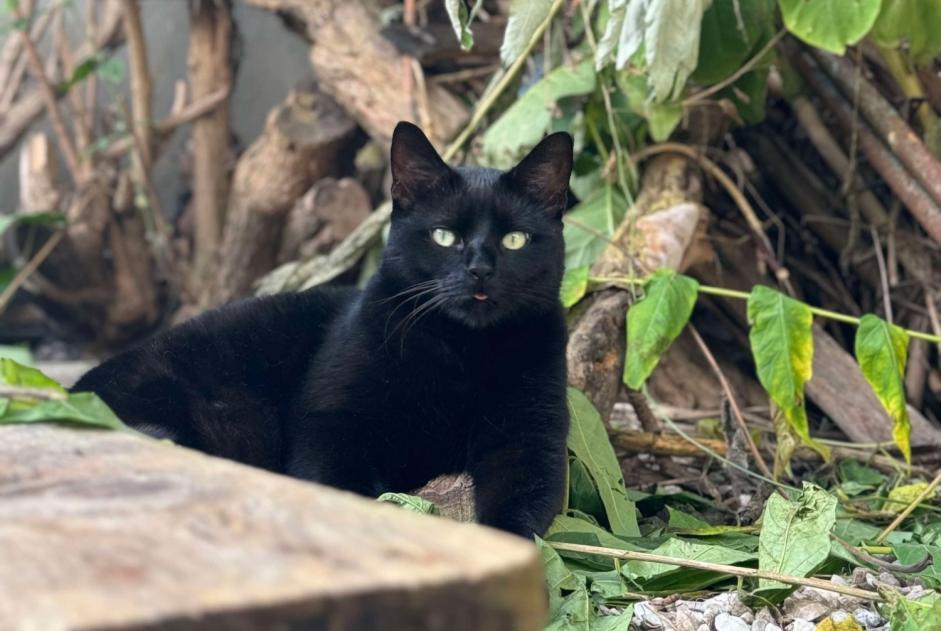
[505,131,572,217]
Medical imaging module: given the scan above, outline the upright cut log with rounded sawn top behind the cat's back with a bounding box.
[200,87,356,307]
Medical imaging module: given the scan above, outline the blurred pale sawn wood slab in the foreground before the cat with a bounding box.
[0,425,545,631]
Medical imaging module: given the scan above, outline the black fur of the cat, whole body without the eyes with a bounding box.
[74,123,572,536]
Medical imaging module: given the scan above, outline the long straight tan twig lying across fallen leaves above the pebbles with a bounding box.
[548,541,884,602]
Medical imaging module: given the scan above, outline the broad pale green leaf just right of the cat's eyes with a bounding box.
[562,184,627,269]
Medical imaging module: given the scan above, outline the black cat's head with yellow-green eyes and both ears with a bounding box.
[382,123,572,328]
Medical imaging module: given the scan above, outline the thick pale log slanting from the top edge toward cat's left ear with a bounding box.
[241,0,467,145]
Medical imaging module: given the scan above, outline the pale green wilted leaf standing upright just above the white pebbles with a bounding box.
[758,482,837,591]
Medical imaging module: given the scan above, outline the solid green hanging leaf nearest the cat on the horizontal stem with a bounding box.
[624,269,699,390]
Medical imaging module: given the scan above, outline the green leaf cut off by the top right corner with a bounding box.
[872,0,941,63]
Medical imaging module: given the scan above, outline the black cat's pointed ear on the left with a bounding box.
[390,121,454,206]
